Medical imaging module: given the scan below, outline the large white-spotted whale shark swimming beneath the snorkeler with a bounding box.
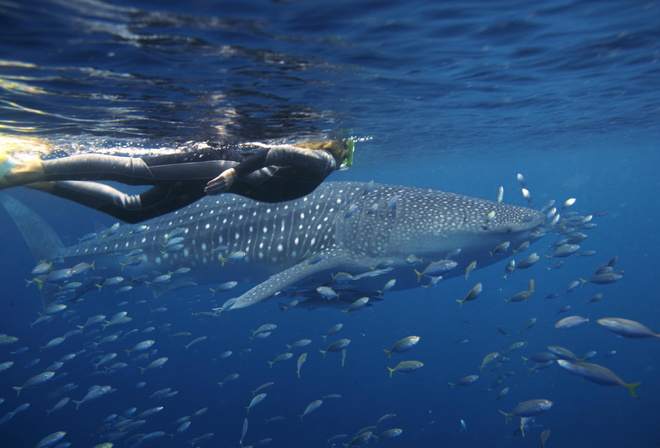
[0,182,545,309]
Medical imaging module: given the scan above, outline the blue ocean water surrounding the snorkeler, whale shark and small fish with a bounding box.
[0,0,660,448]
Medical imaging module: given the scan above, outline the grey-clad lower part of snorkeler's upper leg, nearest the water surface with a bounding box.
[0,154,154,189]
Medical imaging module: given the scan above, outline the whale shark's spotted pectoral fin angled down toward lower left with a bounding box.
[230,249,354,310]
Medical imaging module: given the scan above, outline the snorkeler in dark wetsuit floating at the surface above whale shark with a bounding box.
[0,140,354,223]
